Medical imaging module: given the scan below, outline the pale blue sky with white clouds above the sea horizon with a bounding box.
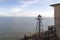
[0,0,60,17]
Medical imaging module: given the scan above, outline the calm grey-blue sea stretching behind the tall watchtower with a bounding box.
[0,17,54,40]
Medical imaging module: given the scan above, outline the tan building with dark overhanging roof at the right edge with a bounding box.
[51,3,60,40]
